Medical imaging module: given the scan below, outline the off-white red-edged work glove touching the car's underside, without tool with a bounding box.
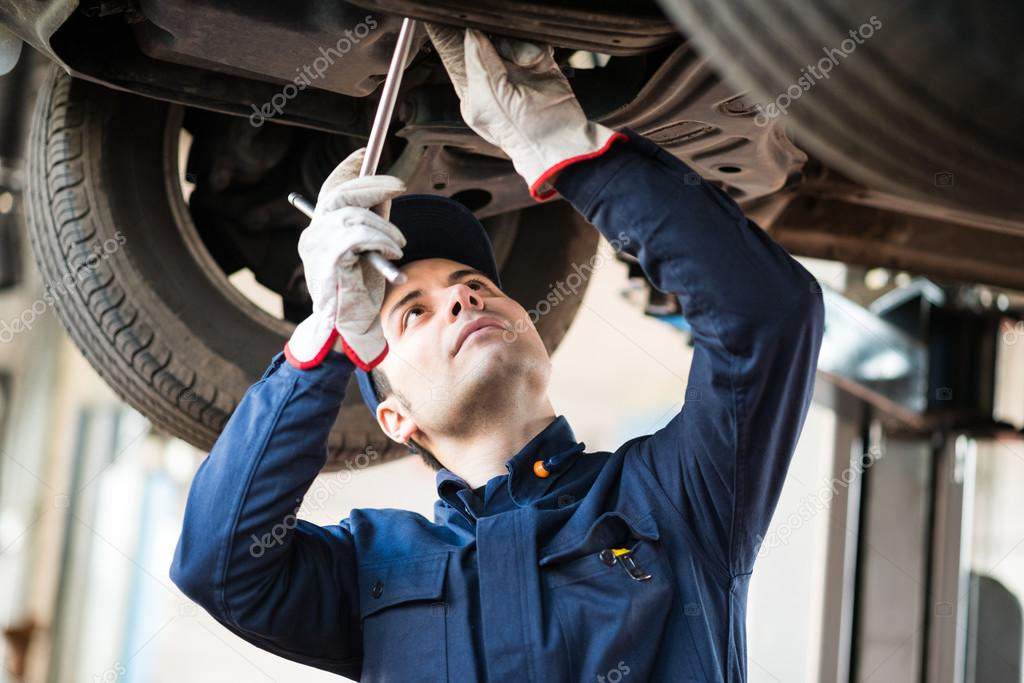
[426,24,627,200]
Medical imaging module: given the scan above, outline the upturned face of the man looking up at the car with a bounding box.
[378,258,551,445]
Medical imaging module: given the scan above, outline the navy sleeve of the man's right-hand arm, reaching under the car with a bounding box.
[555,128,824,575]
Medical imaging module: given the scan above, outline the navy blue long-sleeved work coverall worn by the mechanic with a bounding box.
[171,128,824,683]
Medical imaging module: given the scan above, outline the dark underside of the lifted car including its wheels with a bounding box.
[0,0,1024,463]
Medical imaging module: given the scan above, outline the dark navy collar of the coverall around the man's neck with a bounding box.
[436,415,586,522]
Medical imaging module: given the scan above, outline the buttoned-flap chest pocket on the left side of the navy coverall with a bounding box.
[359,553,449,683]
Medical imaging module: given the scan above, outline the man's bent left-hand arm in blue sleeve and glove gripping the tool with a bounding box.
[171,141,406,678]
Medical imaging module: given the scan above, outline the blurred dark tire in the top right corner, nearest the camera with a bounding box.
[659,0,1024,220]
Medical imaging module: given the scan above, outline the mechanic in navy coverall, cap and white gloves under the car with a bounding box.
[171,26,823,683]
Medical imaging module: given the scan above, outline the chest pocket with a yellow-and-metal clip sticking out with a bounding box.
[539,512,674,681]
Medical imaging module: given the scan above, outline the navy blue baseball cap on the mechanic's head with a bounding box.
[355,195,502,415]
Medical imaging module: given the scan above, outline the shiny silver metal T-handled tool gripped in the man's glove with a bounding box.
[288,17,416,285]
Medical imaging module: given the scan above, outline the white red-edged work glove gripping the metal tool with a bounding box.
[285,147,406,372]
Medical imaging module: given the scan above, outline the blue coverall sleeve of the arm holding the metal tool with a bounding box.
[170,350,362,678]
